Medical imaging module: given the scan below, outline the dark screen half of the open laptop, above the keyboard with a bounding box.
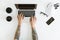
[15,4,37,9]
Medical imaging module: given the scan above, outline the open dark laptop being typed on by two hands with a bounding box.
[15,4,37,17]
